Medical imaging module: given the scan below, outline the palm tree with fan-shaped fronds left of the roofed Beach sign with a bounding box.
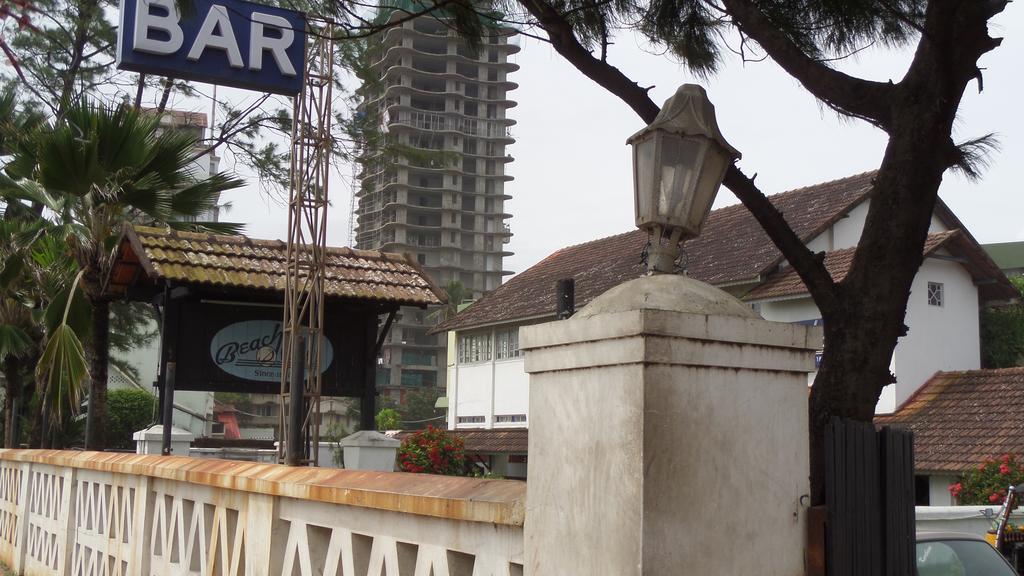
[0,102,243,449]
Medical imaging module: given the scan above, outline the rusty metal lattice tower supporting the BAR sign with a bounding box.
[278,20,335,466]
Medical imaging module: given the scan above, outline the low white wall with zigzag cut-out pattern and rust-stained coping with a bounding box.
[0,450,525,576]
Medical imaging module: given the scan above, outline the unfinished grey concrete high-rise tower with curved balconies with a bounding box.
[354,7,519,401]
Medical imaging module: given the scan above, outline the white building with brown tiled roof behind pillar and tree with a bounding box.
[438,172,1015,429]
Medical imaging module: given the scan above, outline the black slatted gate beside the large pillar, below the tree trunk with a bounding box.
[825,419,914,576]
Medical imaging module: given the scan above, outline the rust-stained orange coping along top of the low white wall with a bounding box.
[0,449,526,527]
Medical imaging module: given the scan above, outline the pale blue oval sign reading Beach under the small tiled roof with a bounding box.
[210,320,334,382]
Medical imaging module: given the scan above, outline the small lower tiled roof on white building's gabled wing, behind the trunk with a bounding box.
[743,230,1017,301]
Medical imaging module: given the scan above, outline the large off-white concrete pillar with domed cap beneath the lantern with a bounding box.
[519,275,821,576]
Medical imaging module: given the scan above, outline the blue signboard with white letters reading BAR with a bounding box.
[118,0,306,95]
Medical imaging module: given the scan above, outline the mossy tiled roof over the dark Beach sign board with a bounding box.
[106,225,444,305]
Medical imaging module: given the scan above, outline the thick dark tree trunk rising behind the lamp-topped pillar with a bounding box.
[810,48,968,504]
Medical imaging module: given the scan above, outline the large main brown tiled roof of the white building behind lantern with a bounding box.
[434,172,874,331]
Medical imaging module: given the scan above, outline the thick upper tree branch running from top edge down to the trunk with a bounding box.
[722,0,893,129]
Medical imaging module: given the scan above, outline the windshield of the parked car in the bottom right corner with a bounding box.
[918,540,1016,576]
